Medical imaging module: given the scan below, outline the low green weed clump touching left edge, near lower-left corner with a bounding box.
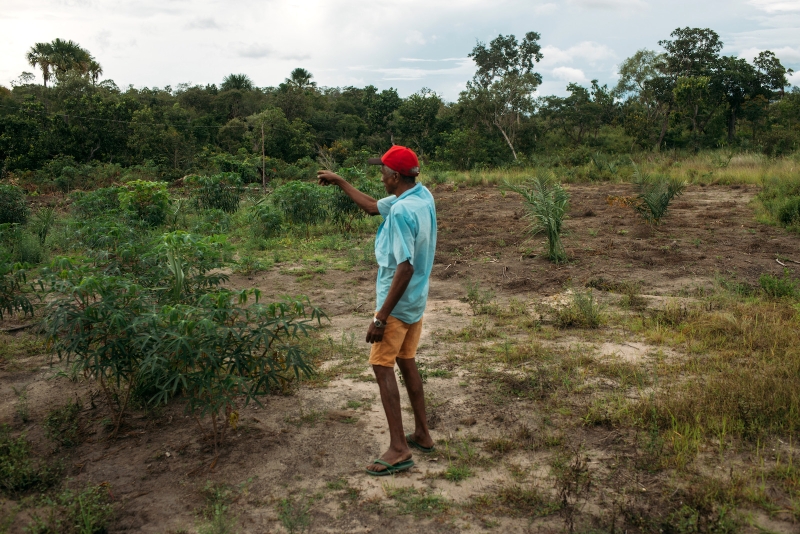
[0,425,60,496]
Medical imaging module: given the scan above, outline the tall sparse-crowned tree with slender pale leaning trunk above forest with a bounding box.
[459,32,542,159]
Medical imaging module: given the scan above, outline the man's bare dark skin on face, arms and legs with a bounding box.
[317,165,433,472]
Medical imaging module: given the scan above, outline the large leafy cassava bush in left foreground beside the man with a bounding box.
[46,232,324,443]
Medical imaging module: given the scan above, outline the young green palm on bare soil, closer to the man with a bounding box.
[505,173,569,263]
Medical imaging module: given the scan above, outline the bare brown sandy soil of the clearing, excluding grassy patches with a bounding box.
[0,184,800,533]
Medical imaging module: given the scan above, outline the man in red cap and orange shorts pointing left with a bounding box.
[317,146,436,476]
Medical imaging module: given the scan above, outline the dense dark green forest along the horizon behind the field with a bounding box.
[0,28,800,191]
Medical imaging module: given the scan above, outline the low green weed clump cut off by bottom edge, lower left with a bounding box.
[28,485,114,534]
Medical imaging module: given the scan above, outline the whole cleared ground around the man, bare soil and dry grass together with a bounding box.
[0,184,800,533]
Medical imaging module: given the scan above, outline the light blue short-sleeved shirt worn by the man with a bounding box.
[375,183,436,324]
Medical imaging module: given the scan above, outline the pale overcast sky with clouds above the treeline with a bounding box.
[0,0,800,100]
